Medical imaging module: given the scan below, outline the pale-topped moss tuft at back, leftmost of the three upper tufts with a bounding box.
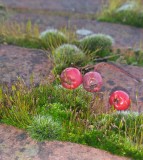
[40,29,68,49]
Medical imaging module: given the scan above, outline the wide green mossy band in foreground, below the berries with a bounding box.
[0,82,143,160]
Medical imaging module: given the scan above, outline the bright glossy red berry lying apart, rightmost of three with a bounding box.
[109,90,131,111]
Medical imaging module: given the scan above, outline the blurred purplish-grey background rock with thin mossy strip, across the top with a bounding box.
[1,0,143,48]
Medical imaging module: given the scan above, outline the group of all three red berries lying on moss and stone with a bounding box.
[60,67,131,110]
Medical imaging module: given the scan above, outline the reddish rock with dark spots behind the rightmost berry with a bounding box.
[96,62,143,112]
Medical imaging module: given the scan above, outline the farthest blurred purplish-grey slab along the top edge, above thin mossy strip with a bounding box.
[1,0,103,13]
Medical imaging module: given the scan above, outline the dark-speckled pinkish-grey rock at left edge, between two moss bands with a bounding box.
[0,45,52,84]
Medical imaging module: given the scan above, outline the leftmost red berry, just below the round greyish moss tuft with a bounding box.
[60,67,82,89]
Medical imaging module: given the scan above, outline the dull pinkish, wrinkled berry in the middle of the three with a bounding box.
[83,71,103,92]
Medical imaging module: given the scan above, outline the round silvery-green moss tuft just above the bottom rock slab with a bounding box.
[27,115,62,141]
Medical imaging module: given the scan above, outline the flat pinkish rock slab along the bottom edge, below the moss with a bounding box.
[0,124,130,160]
